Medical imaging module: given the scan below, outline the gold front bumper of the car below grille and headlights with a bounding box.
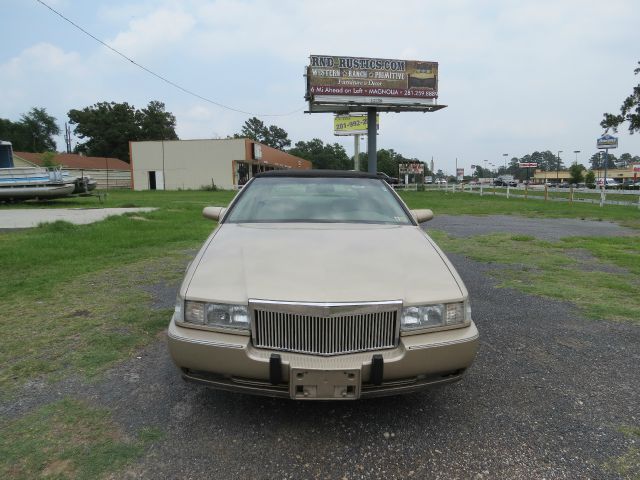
[168,321,478,397]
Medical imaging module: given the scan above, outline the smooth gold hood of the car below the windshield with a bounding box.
[183,224,467,305]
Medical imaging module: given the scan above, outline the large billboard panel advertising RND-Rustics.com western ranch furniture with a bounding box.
[306,55,438,106]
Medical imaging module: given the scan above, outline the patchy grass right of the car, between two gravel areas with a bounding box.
[430,230,640,324]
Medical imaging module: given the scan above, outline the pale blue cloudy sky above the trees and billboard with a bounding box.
[0,0,640,174]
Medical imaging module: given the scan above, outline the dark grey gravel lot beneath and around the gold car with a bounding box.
[4,216,640,479]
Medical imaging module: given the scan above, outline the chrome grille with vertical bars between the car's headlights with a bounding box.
[250,302,401,355]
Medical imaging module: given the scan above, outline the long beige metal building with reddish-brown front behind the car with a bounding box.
[129,138,311,190]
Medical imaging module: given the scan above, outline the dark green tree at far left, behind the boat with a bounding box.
[0,107,60,152]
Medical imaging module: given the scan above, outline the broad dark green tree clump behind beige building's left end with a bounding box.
[68,101,178,162]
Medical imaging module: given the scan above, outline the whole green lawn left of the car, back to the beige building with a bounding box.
[0,192,233,397]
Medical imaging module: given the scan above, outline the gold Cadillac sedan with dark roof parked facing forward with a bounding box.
[168,170,478,400]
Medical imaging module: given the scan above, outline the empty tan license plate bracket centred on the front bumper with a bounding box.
[289,368,361,400]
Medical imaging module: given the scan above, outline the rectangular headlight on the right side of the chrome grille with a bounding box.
[400,301,471,332]
